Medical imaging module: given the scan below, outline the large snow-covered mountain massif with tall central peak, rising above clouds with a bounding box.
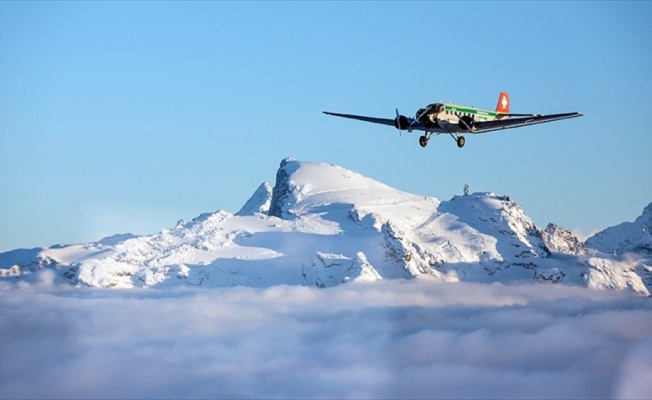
[0,159,652,295]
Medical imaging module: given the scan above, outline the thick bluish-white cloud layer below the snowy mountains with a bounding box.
[0,275,652,398]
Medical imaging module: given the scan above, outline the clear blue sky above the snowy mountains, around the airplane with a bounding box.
[0,1,652,251]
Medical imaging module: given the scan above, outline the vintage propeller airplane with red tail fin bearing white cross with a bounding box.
[323,92,584,148]
